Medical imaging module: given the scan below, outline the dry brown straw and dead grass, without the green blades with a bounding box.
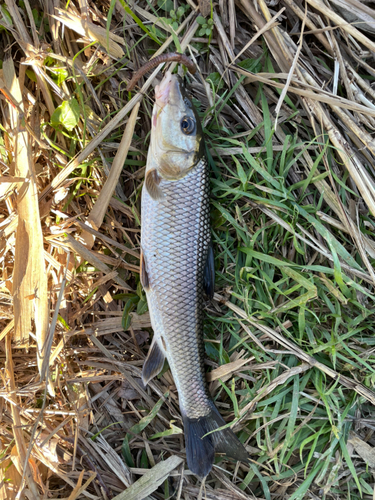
[0,0,375,500]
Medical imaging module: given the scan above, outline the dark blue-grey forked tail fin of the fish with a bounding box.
[183,403,249,478]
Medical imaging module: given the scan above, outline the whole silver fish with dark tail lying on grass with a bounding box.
[140,72,248,478]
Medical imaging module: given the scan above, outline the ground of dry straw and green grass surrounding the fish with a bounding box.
[0,0,375,500]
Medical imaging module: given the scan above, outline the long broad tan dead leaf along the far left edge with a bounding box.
[4,58,48,360]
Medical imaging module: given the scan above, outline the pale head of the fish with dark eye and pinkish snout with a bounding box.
[152,71,203,181]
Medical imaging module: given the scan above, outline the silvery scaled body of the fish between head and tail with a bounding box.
[142,160,210,418]
